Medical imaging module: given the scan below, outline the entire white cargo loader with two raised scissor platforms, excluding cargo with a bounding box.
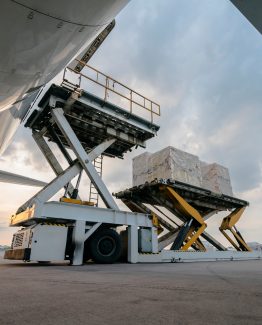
[5,62,261,265]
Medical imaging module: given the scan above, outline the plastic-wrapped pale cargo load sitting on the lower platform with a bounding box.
[133,146,233,196]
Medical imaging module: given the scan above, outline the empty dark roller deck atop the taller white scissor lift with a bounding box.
[26,84,159,158]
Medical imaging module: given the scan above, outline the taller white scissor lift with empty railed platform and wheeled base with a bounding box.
[5,62,160,265]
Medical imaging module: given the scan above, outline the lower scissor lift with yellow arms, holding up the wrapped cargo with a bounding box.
[114,179,261,262]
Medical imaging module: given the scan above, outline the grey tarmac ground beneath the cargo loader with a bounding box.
[0,251,262,325]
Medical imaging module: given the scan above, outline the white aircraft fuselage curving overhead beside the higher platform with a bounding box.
[0,0,129,153]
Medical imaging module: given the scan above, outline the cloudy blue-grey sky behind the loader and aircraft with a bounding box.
[0,0,262,244]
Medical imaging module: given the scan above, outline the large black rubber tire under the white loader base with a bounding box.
[89,228,122,264]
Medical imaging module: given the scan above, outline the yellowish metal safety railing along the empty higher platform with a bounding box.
[62,59,160,123]
